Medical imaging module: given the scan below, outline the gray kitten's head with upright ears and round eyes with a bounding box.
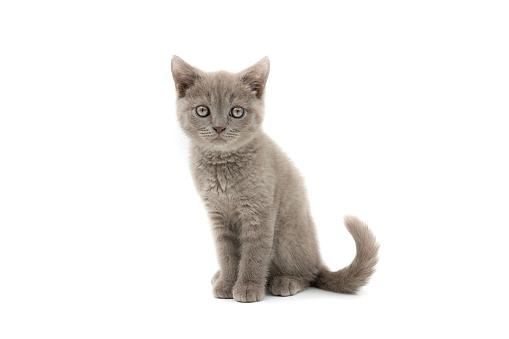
[171,56,269,151]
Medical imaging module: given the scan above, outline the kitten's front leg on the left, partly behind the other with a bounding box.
[209,212,239,299]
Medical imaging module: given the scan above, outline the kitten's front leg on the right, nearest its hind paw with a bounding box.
[233,212,274,302]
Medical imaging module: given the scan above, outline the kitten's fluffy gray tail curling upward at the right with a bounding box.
[313,216,380,294]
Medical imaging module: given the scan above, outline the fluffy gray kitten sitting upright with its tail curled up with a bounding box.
[171,56,378,302]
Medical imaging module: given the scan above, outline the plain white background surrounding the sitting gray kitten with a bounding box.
[0,1,509,339]
